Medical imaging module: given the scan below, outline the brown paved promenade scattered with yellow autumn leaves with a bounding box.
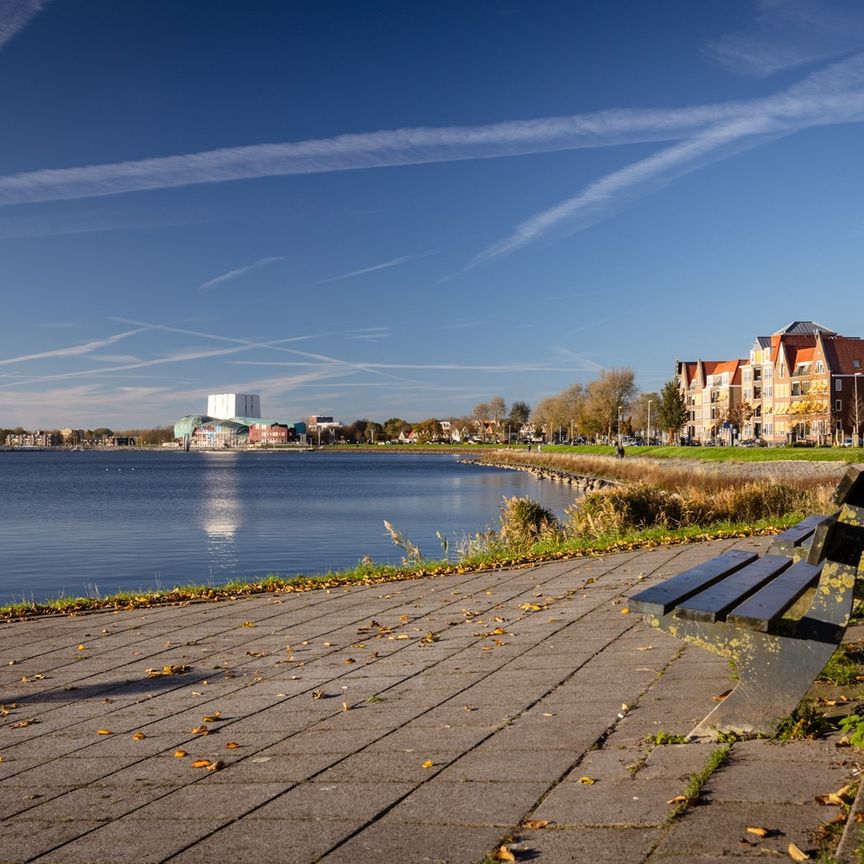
[0,540,857,864]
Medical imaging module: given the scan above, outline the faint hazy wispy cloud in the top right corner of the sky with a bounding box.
[705,0,864,78]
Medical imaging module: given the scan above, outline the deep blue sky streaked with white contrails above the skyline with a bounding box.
[0,0,864,428]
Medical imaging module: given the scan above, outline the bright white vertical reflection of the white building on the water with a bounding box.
[200,453,243,575]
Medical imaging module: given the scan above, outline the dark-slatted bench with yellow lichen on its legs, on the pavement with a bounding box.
[629,465,864,736]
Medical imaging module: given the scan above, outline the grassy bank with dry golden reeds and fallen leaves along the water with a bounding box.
[0,448,834,620]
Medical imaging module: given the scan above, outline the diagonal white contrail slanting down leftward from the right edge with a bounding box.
[466,54,864,269]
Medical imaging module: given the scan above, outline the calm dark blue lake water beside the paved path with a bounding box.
[0,451,575,603]
